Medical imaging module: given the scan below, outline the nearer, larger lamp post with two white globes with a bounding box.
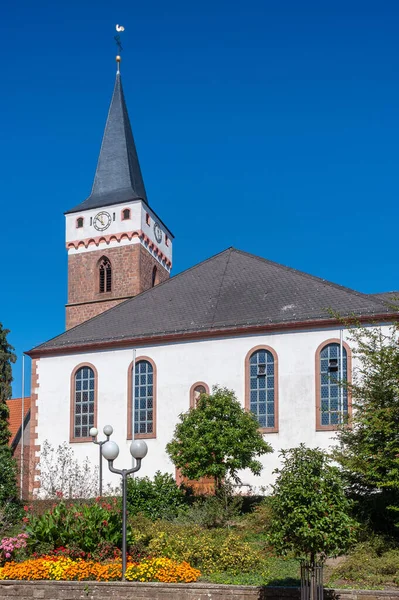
[101,440,148,581]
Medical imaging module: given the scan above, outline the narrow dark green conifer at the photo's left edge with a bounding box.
[0,323,19,518]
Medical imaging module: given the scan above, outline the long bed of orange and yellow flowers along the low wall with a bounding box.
[0,556,201,583]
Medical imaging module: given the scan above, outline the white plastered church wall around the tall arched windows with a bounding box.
[37,329,378,494]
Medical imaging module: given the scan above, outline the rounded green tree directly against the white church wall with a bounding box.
[166,387,272,490]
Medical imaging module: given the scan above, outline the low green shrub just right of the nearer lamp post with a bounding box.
[127,471,191,520]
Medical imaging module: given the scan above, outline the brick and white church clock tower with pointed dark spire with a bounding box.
[66,64,173,329]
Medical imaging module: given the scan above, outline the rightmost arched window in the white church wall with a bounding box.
[316,340,351,430]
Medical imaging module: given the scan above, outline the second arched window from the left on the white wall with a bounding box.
[127,356,156,439]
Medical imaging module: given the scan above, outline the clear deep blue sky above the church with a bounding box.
[0,0,399,396]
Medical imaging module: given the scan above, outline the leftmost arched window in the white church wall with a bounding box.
[71,364,97,442]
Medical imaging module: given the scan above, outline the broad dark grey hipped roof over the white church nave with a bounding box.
[30,248,396,355]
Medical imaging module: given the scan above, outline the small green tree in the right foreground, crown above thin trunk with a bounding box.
[268,444,356,564]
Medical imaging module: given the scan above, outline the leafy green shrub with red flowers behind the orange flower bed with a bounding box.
[26,498,122,552]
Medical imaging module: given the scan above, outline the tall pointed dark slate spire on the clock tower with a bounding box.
[67,73,148,213]
